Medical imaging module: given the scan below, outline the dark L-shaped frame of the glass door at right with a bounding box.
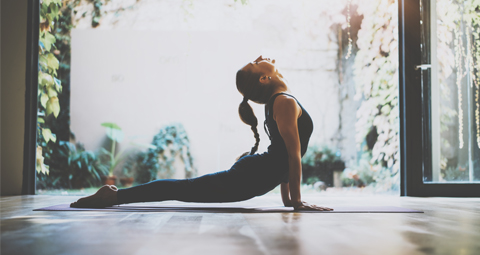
[398,0,480,197]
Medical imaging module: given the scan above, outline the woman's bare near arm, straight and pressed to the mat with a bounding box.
[273,95,332,211]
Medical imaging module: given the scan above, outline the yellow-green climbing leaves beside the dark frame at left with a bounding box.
[37,0,139,188]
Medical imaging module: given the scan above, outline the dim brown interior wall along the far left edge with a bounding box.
[0,0,28,195]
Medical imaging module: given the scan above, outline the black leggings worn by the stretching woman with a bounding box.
[117,153,288,204]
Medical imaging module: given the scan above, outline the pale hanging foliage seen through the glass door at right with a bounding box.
[436,0,480,181]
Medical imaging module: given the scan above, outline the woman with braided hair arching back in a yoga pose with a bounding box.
[70,56,332,211]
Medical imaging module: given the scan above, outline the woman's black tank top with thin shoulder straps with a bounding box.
[264,93,313,160]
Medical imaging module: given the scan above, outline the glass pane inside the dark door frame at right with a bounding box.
[421,0,480,183]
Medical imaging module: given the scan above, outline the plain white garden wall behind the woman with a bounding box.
[71,0,348,174]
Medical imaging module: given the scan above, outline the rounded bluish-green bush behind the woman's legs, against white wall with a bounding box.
[136,123,196,183]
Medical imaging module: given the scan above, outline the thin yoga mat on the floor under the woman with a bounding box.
[34,204,423,213]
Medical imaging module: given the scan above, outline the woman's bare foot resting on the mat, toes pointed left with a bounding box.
[70,185,118,208]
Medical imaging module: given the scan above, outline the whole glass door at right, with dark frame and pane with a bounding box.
[398,0,480,197]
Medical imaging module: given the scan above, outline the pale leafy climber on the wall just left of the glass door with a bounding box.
[354,0,399,187]
